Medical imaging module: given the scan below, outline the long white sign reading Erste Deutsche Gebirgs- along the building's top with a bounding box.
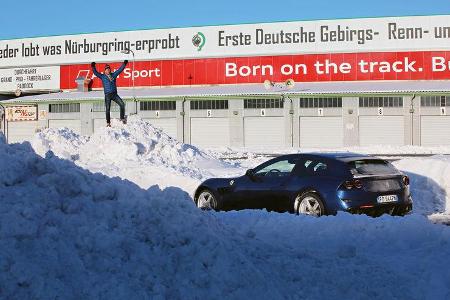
[0,15,450,68]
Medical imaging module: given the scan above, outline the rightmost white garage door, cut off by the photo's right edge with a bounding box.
[420,116,450,146]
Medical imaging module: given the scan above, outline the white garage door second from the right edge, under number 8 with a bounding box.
[359,116,405,146]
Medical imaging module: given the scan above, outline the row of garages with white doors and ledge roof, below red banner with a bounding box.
[3,81,450,150]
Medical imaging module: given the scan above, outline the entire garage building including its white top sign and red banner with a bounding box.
[0,15,450,151]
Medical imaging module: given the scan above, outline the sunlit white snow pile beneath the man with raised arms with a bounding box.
[32,116,236,189]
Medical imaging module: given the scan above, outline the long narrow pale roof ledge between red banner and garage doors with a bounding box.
[3,80,450,103]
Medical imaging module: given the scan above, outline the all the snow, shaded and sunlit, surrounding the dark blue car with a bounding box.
[0,117,450,299]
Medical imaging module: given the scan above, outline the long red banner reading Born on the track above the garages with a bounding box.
[61,51,450,89]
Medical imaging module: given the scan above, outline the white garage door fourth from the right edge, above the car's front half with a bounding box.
[244,117,286,148]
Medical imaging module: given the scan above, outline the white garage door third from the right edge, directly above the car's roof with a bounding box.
[300,117,344,148]
